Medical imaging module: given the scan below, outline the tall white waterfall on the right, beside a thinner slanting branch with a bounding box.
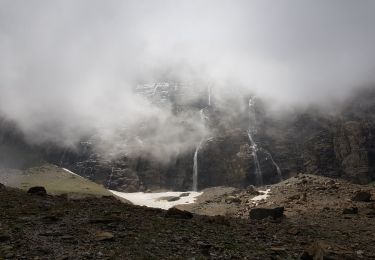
[247,98,263,185]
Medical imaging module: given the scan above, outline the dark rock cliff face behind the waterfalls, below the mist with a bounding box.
[0,85,375,192]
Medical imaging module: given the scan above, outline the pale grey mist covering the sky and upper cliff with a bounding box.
[0,0,375,160]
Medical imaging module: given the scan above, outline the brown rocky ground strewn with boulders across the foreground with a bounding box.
[0,175,375,259]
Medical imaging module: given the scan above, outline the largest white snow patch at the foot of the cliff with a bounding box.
[109,190,203,209]
